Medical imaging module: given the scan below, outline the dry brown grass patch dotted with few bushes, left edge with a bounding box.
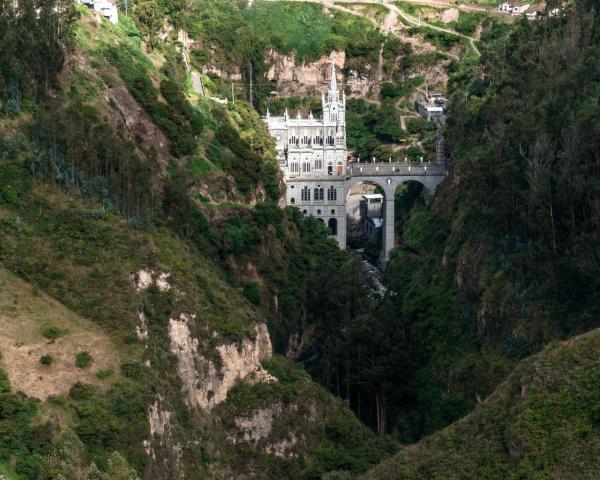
[0,269,120,399]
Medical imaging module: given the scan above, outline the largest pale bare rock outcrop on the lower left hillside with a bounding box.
[169,314,276,410]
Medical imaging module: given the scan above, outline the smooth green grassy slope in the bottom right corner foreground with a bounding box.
[365,330,600,480]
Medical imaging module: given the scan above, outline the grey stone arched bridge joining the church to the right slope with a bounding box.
[344,162,448,263]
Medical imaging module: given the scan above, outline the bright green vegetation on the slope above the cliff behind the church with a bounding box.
[186,0,383,68]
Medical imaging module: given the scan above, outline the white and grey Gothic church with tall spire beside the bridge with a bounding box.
[264,65,347,248]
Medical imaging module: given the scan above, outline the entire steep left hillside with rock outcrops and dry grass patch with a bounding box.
[0,4,395,480]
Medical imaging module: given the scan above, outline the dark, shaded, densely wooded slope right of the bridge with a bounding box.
[310,1,600,446]
